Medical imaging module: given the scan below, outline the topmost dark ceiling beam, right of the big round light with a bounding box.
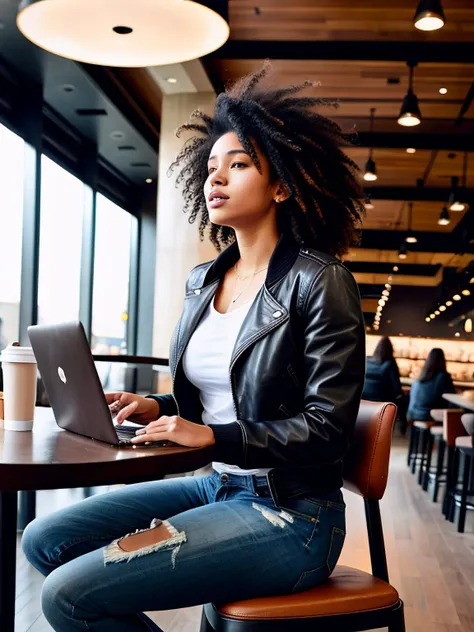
[209,40,474,64]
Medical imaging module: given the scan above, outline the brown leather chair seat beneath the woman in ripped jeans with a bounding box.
[217,566,399,621]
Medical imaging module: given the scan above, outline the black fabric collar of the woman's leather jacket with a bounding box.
[202,230,300,288]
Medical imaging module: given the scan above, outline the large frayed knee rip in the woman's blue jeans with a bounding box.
[104,518,186,568]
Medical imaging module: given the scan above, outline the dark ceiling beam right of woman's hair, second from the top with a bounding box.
[355,132,474,151]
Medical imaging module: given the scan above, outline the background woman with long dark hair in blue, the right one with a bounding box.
[407,349,456,421]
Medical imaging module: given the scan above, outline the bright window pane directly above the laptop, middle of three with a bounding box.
[38,156,85,324]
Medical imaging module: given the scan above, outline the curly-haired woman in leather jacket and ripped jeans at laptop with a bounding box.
[23,68,365,632]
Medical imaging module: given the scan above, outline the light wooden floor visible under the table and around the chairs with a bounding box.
[15,439,474,632]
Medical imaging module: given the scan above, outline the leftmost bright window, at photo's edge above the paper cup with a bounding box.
[0,125,25,350]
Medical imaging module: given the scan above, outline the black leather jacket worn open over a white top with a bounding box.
[152,235,365,505]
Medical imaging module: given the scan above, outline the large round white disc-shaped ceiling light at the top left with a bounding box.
[17,0,229,68]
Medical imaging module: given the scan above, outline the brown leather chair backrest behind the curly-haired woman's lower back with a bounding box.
[343,400,397,500]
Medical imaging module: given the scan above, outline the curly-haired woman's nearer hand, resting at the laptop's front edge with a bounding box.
[131,415,215,448]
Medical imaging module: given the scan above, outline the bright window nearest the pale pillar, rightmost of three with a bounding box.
[91,193,137,354]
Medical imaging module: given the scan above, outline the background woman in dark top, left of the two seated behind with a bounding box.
[362,336,403,402]
